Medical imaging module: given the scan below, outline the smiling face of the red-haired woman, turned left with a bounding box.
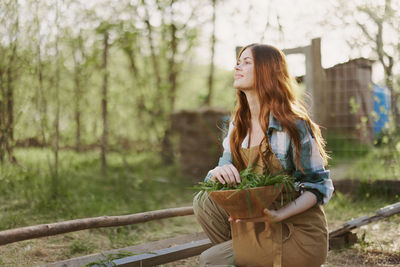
[233,48,254,90]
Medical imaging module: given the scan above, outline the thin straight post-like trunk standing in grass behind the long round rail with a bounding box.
[101,30,109,175]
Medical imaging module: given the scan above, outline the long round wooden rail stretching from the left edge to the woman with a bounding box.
[0,206,193,245]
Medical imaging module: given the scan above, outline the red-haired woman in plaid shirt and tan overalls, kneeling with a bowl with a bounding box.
[193,44,333,267]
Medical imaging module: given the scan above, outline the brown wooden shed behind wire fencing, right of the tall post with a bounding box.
[322,58,374,144]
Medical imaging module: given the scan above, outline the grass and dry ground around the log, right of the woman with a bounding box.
[325,193,400,267]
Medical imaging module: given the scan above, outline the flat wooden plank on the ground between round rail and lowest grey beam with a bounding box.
[48,232,207,267]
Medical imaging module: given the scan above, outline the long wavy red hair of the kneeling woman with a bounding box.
[230,44,328,171]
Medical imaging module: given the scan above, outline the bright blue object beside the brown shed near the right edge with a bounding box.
[372,84,390,136]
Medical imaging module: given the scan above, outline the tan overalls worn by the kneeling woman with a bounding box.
[193,142,328,267]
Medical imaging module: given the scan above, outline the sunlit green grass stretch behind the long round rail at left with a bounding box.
[0,149,193,231]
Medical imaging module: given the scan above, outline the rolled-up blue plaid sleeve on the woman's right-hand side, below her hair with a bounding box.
[291,120,334,204]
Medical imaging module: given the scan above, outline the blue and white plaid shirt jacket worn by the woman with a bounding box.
[205,113,334,204]
